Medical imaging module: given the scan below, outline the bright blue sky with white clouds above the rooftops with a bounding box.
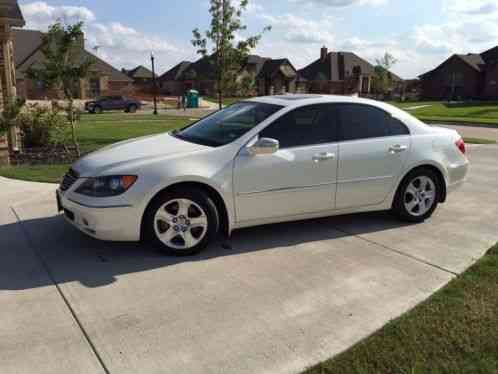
[19,0,498,79]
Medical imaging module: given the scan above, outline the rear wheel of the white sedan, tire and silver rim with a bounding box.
[392,168,442,223]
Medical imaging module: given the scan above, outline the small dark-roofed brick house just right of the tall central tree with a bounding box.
[256,58,299,96]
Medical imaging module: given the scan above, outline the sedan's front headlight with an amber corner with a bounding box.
[75,175,137,197]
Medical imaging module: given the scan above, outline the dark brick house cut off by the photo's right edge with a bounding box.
[420,46,498,100]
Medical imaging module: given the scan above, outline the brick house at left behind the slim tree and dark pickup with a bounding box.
[13,29,133,100]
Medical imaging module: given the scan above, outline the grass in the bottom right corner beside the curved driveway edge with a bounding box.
[305,245,498,374]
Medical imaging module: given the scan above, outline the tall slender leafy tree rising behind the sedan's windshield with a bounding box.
[192,0,271,109]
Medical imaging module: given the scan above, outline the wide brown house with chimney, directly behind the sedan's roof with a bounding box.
[298,47,402,95]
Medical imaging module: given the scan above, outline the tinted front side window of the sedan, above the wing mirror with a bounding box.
[259,105,338,148]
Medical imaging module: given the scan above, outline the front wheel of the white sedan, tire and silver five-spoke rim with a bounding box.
[143,188,220,256]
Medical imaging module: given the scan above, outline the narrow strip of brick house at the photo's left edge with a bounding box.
[0,0,25,164]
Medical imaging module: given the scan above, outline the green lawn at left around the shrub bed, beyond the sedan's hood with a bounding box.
[0,113,190,183]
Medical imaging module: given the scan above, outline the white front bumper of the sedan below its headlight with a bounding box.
[57,190,141,242]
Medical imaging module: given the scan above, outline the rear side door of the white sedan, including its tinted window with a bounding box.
[336,104,411,209]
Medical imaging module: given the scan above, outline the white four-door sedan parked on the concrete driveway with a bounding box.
[57,95,469,255]
